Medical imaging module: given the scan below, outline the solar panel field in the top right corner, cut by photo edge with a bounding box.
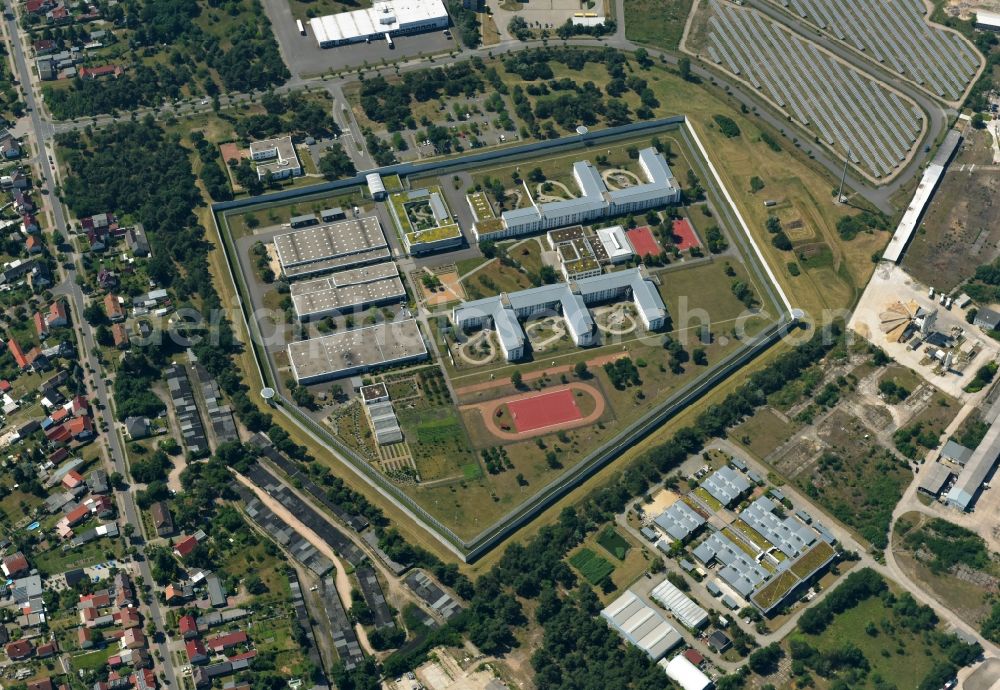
[771,0,982,101]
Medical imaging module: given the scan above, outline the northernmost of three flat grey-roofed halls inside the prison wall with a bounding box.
[274,216,389,279]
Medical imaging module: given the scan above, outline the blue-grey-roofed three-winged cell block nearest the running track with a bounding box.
[451,268,667,361]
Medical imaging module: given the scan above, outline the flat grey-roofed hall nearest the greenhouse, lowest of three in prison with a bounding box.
[288,319,427,385]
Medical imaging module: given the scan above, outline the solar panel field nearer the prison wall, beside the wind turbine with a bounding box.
[705,0,923,179]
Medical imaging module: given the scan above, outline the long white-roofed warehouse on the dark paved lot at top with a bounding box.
[309,0,449,48]
